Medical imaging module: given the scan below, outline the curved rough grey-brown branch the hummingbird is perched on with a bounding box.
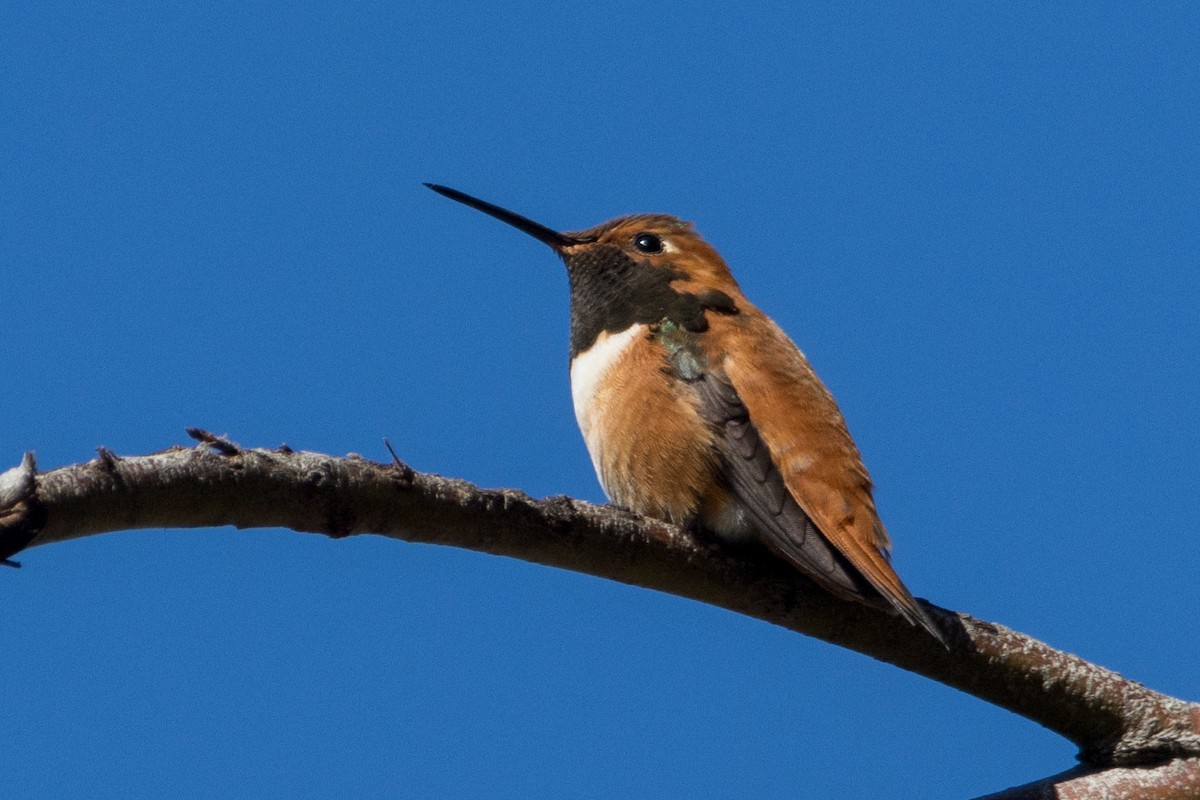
[0,429,1200,800]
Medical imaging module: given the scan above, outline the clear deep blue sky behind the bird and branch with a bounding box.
[0,1,1200,799]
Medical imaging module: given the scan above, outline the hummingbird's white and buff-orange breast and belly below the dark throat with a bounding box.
[571,324,716,524]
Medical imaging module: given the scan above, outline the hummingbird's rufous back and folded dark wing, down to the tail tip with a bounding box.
[696,308,942,639]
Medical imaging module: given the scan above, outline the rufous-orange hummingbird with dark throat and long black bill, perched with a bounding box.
[426,184,946,645]
